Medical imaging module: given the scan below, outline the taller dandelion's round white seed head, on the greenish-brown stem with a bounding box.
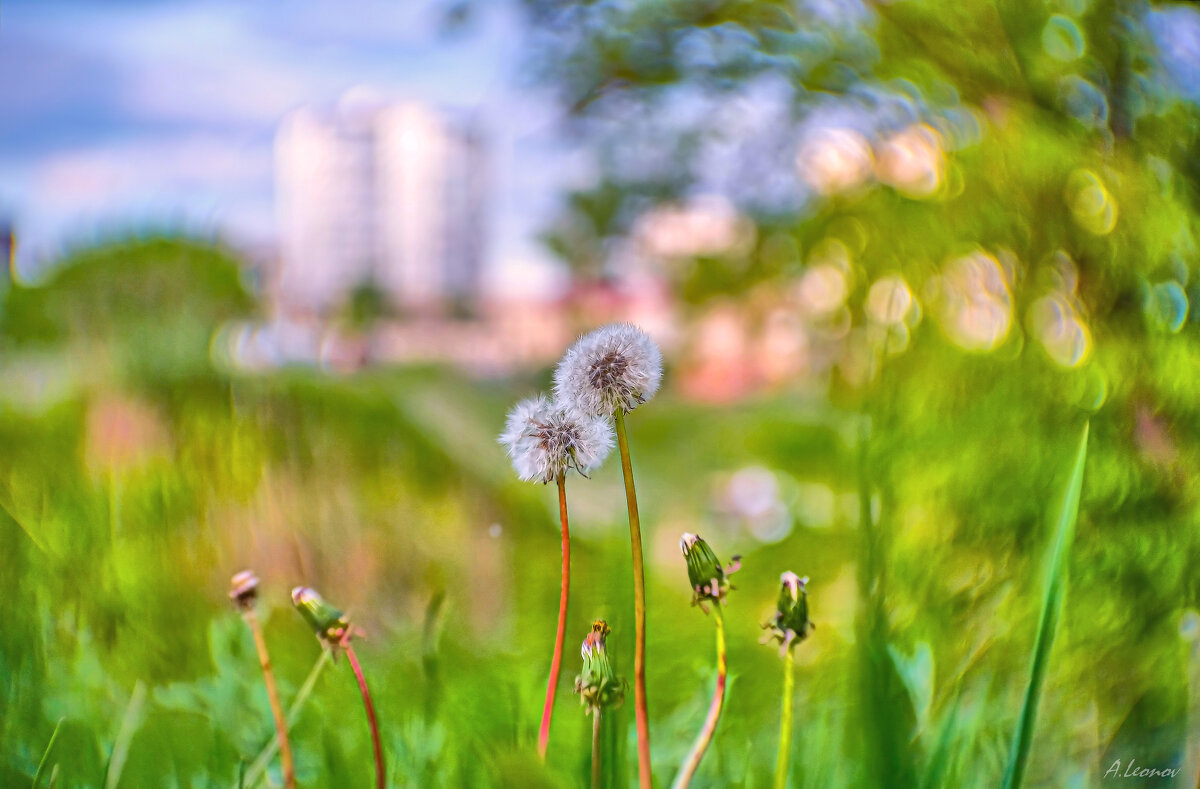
[554,324,662,416]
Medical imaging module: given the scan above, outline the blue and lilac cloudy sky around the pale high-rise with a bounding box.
[0,0,586,291]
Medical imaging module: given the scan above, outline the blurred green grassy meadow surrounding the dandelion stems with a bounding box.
[0,240,1196,787]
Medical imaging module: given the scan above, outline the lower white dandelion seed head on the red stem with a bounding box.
[500,395,612,482]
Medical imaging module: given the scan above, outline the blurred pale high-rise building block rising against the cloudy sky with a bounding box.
[276,95,486,312]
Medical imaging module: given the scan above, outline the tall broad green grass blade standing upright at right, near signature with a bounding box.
[1003,422,1087,789]
